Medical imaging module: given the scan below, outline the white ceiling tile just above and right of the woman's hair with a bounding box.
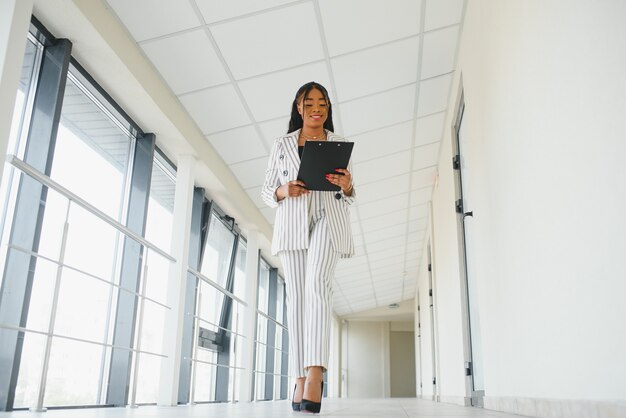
[331,36,419,101]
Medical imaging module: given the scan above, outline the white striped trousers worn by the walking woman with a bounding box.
[278,198,339,377]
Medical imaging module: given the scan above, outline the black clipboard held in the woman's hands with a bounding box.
[298,141,354,192]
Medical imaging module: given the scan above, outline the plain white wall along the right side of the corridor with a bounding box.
[418,0,626,415]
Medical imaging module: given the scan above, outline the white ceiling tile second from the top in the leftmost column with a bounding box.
[141,29,229,94]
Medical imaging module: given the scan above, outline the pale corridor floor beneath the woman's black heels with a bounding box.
[0,398,521,418]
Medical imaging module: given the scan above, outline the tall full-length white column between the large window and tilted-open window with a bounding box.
[157,155,196,406]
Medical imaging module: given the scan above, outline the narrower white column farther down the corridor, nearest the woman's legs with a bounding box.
[239,231,259,402]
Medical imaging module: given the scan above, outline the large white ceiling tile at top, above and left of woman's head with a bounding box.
[211,2,324,79]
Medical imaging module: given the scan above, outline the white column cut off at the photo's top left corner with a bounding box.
[0,0,33,181]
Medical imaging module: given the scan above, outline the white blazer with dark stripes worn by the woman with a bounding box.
[261,130,356,258]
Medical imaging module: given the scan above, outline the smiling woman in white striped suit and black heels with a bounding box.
[261,82,355,412]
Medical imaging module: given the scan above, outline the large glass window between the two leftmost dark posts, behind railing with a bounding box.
[15,63,134,408]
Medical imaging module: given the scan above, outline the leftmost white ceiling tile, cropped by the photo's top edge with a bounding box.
[107,0,201,42]
